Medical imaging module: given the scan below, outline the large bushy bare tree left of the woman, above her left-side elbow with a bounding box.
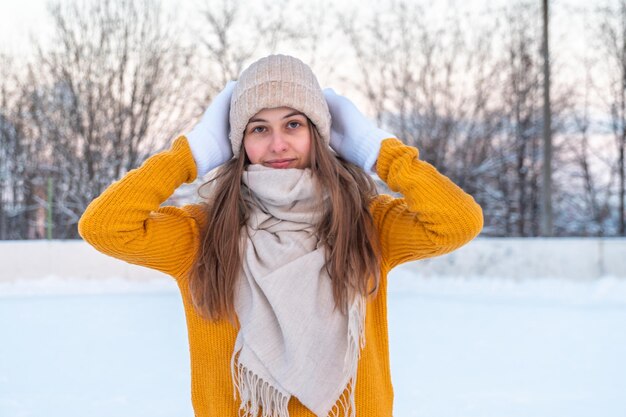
[22,0,191,238]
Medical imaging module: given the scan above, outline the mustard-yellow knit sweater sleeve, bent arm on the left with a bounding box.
[78,136,201,277]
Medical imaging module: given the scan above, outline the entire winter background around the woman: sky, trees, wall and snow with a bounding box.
[0,0,626,417]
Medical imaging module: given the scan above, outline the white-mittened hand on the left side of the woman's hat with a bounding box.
[185,81,237,177]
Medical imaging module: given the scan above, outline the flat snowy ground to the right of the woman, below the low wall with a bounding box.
[389,273,626,417]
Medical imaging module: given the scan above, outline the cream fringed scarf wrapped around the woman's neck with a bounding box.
[231,165,365,417]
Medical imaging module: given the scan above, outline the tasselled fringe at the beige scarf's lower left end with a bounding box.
[231,354,290,417]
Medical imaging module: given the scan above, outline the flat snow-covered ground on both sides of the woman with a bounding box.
[0,267,626,417]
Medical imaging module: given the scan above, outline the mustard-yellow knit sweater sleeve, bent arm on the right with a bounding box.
[371,138,483,269]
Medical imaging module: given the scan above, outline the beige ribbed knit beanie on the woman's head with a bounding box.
[230,55,330,157]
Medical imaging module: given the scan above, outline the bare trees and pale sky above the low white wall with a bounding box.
[0,0,626,236]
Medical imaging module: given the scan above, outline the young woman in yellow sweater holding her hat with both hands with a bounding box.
[79,55,483,417]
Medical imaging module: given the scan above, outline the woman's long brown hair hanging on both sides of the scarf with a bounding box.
[189,120,380,323]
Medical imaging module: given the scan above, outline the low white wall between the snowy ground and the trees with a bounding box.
[0,238,626,282]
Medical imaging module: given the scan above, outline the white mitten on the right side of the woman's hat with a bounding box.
[324,88,395,174]
